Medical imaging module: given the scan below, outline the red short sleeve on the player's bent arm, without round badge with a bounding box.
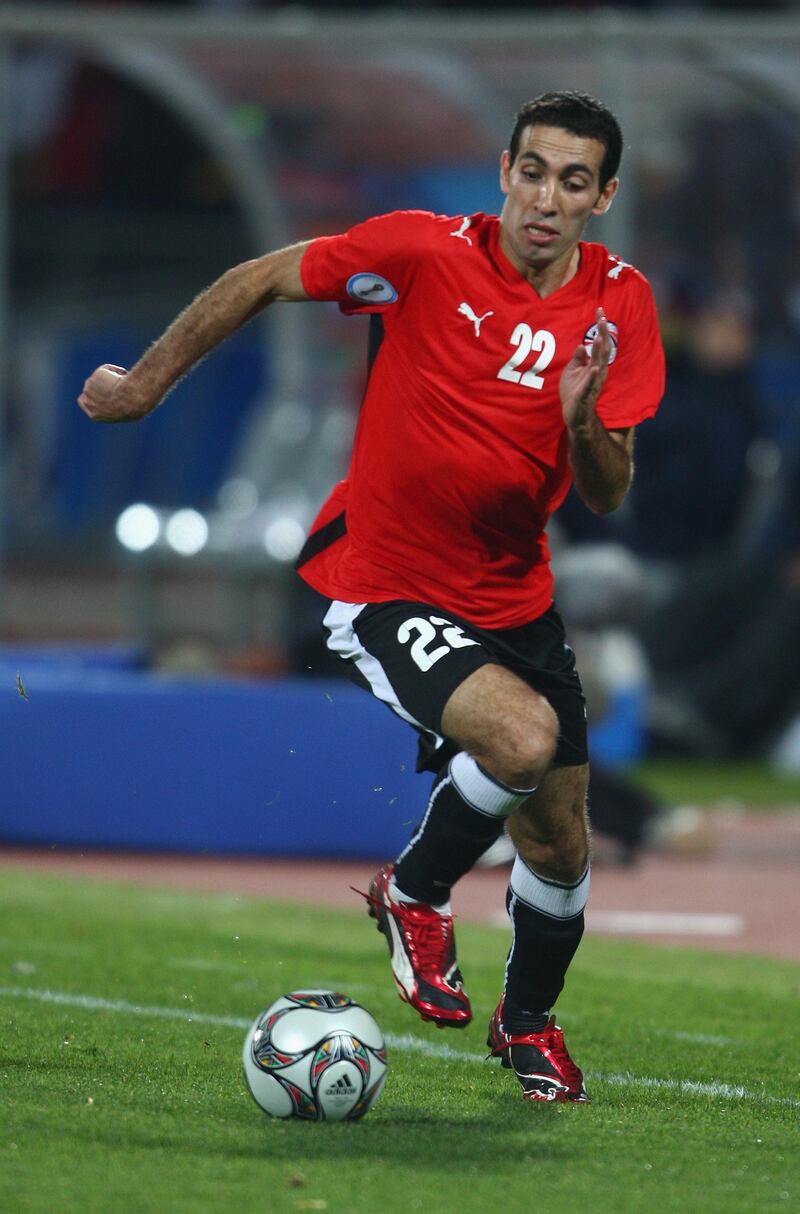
[597,271,664,430]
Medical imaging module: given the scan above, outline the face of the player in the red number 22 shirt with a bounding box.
[500,125,618,277]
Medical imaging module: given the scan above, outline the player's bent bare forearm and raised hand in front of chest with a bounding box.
[560,308,634,515]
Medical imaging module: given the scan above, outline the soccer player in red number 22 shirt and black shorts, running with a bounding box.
[79,92,664,1101]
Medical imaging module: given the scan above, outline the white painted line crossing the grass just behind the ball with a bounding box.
[0,987,800,1107]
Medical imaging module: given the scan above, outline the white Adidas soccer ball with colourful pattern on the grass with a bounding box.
[243,991,386,1122]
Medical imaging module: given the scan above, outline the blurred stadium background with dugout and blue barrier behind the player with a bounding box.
[0,0,800,860]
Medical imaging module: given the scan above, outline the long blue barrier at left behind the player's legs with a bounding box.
[0,670,630,858]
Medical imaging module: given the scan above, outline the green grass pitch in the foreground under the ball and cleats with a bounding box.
[0,870,800,1214]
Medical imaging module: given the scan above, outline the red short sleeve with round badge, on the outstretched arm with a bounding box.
[300,211,436,313]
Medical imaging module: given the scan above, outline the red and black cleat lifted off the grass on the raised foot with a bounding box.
[356,864,472,1028]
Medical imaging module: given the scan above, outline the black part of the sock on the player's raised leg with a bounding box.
[395,767,505,906]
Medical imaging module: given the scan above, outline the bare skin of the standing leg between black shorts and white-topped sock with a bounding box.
[506,764,589,881]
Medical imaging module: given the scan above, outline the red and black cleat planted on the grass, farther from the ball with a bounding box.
[486,999,589,1104]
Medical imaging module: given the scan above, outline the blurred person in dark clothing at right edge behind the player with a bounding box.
[626,290,800,756]
